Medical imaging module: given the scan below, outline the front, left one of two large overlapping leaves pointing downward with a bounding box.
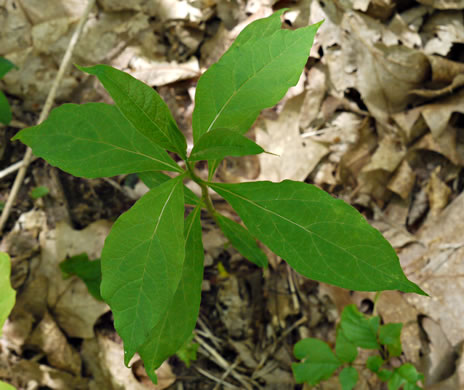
[101,176,185,365]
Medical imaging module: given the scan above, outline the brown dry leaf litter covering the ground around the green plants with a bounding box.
[0,0,464,389]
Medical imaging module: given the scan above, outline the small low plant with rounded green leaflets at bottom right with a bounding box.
[292,305,424,390]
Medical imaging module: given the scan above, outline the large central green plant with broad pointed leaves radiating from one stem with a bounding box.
[10,10,424,381]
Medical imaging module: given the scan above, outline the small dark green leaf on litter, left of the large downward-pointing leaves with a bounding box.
[60,253,103,301]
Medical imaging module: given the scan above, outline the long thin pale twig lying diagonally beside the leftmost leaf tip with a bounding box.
[0,0,95,232]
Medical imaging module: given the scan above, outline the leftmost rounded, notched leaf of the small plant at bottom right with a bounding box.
[292,338,342,386]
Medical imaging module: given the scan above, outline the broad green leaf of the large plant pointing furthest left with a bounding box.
[13,103,182,178]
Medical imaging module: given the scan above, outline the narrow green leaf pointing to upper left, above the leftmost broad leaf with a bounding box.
[78,65,187,160]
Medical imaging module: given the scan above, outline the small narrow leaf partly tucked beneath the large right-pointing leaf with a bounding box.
[216,214,267,267]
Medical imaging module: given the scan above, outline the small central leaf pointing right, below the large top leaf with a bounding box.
[189,129,264,161]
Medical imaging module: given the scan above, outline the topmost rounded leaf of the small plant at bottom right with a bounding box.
[340,305,380,349]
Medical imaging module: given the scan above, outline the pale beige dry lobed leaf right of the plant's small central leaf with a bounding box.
[256,95,328,181]
